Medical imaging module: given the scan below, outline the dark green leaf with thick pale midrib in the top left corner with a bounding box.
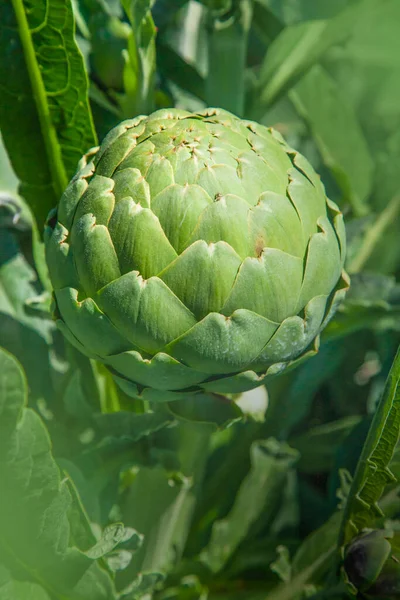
[0,0,95,230]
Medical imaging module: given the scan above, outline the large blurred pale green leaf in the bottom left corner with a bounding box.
[0,350,116,600]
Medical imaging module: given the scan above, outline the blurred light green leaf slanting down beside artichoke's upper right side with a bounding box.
[289,65,374,216]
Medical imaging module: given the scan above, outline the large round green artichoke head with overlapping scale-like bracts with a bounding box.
[46,109,348,401]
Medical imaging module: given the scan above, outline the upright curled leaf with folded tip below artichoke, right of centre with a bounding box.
[201,438,298,572]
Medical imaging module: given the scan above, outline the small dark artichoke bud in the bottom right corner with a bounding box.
[344,529,400,600]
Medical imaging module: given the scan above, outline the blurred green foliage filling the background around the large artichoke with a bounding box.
[0,0,400,600]
